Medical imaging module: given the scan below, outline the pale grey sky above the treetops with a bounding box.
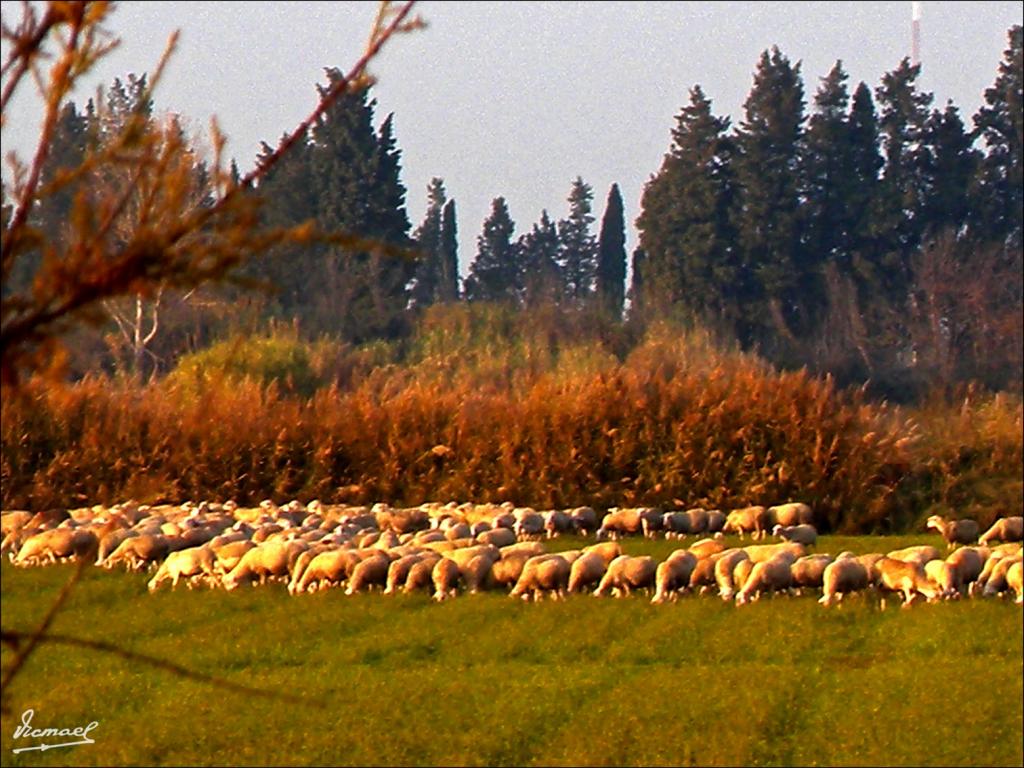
[0,0,1024,276]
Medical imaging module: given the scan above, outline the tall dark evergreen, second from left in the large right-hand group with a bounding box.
[736,47,807,348]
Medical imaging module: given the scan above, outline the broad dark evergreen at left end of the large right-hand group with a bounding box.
[631,86,741,327]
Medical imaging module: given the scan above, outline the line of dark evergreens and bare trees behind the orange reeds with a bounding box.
[3,26,1024,397]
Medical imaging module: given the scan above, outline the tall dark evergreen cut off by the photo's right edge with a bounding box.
[974,25,1024,249]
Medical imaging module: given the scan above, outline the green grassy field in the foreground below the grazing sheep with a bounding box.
[2,536,1024,766]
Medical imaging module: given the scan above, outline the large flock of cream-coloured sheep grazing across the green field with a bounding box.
[0,501,1024,605]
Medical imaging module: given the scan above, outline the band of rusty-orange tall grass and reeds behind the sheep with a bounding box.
[0,307,1021,532]
